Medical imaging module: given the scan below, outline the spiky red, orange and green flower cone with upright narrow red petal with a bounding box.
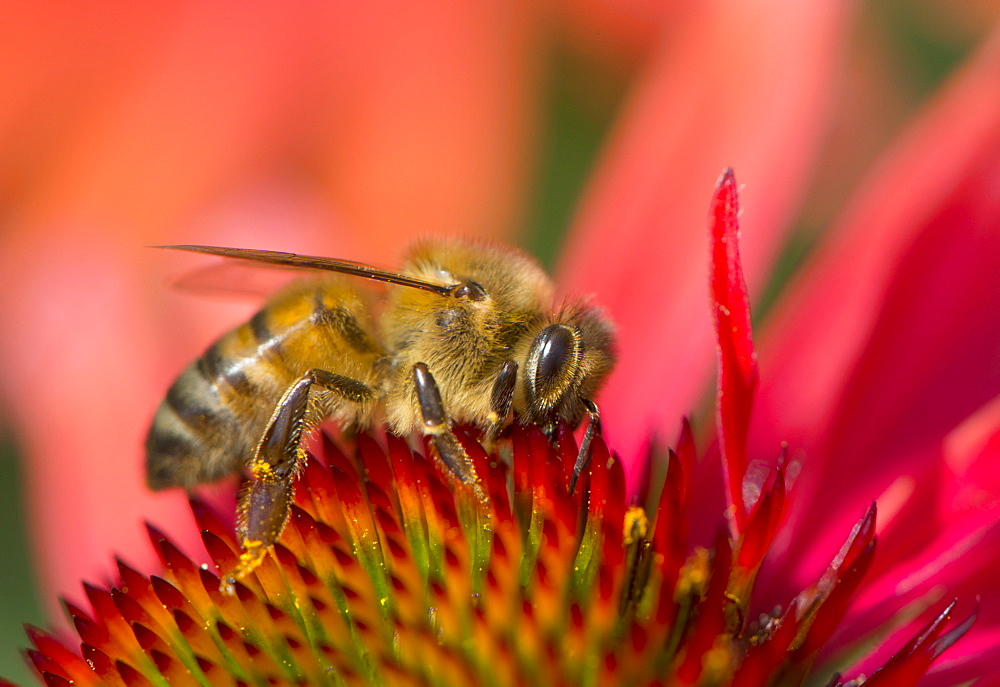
[15,172,974,686]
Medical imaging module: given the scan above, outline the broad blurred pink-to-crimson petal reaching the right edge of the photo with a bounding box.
[751,21,1000,582]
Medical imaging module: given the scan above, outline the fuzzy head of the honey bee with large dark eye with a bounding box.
[523,307,615,431]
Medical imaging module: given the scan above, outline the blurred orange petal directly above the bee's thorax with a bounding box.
[308,0,541,250]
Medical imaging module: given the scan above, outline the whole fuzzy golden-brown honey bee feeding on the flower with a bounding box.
[146,240,614,589]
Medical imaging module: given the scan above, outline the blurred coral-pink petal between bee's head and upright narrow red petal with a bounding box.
[562,0,849,472]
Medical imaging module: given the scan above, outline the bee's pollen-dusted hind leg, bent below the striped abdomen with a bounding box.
[222,369,375,592]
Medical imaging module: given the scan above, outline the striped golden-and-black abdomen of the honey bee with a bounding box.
[146,280,384,489]
